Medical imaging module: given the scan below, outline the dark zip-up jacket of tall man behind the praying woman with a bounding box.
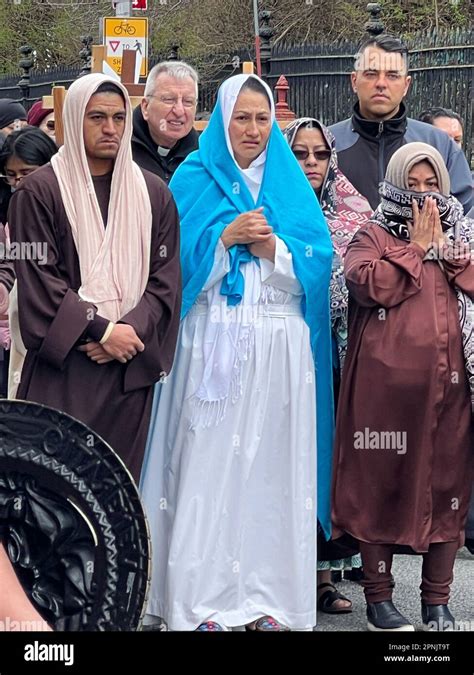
[329,103,474,213]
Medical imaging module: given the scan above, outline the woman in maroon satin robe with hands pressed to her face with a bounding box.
[333,143,474,630]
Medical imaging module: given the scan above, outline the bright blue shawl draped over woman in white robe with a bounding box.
[166,75,333,537]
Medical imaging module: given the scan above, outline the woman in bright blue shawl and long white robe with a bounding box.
[142,75,333,631]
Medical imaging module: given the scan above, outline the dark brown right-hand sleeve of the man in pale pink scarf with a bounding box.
[120,188,181,392]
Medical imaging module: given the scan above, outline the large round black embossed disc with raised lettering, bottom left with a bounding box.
[0,400,150,631]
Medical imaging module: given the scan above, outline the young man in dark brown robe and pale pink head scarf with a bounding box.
[9,74,181,480]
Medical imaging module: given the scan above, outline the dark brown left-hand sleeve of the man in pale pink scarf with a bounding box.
[9,189,104,369]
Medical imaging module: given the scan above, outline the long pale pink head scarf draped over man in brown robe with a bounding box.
[51,73,152,322]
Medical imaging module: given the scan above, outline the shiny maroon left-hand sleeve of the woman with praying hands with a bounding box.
[344,225,425,307]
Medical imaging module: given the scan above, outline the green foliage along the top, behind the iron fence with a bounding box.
[0,0,471,73]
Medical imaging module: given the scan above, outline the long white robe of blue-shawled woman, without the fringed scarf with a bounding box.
[141,237,316,630]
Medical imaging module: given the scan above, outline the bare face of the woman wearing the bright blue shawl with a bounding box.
[229,85,272,169]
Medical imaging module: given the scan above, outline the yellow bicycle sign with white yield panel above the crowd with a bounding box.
[103,17,148,77]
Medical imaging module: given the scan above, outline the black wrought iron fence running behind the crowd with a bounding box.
[0,29,474,165]
